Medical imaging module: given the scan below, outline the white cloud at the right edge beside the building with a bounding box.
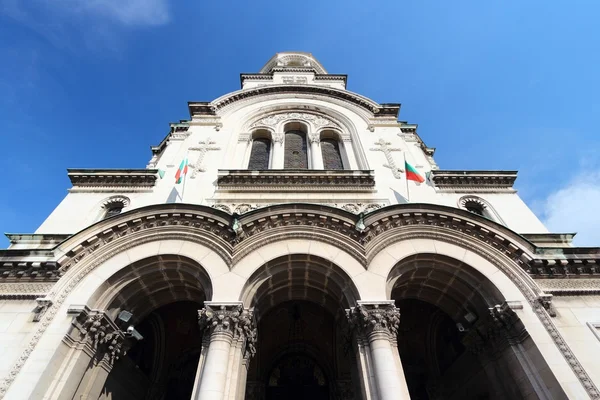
[540,169,600,247]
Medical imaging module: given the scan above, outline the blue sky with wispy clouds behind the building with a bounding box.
[0,0,600,247]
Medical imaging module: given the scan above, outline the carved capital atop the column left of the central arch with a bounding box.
[198,304,258,358]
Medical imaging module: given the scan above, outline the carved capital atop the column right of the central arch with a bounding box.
[346,303,400,341]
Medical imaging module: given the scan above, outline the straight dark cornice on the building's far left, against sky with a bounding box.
[67,169,158,190]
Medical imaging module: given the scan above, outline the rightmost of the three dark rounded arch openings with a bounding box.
[388,253,556,400]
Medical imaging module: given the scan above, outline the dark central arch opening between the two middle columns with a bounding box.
[240,254,360,400]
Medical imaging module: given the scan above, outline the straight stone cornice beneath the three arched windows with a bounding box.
[217,169,375,192]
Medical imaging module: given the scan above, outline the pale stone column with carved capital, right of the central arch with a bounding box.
[346,301,410,400]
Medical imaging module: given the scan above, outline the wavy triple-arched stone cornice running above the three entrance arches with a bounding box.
[0,203,600,282]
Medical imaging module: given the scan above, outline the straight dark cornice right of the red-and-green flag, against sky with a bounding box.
[431,170,517,193]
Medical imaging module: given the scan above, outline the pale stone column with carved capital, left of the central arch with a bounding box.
[193,302,257,400]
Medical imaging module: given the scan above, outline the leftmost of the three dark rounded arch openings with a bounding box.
[90,255,212,400]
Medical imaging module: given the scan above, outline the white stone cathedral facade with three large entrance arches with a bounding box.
[0,52,600,400]
